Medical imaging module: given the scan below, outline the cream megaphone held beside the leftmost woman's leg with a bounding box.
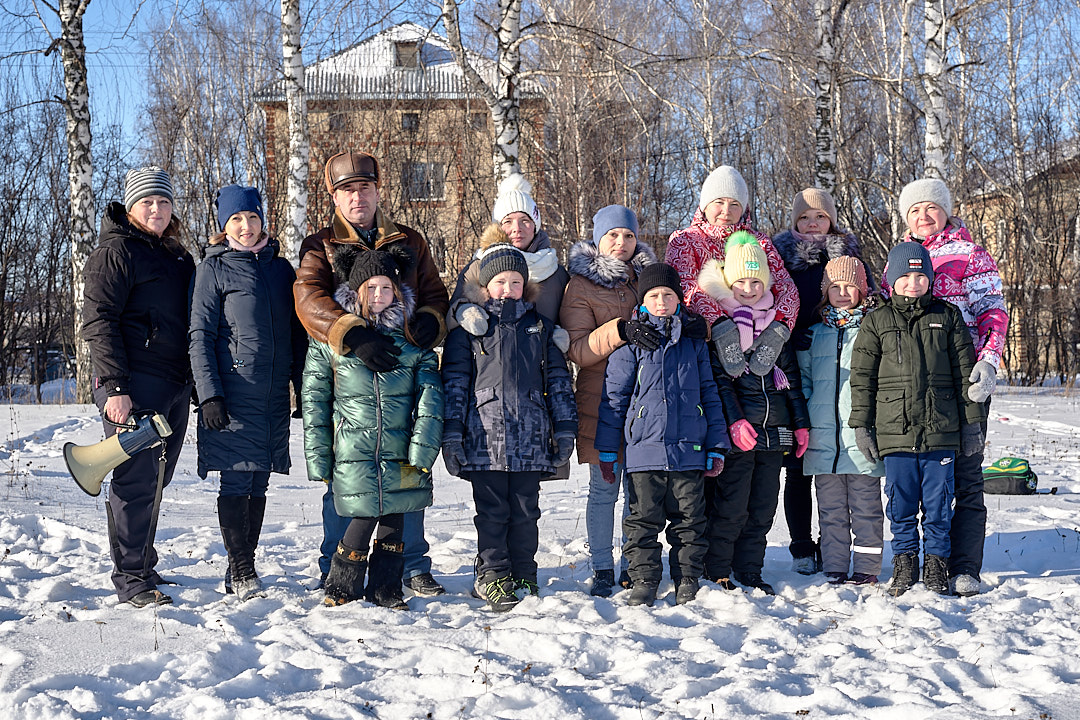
[64,410,173,498]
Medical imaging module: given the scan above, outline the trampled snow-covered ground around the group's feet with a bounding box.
[0,391,1080,720]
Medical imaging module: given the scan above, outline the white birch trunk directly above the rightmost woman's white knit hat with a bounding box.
[921,0,949,180]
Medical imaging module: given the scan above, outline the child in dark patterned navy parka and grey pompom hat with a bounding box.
[443,235,578,612]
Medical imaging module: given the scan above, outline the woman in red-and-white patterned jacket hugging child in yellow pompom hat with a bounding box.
[664,165,799,377]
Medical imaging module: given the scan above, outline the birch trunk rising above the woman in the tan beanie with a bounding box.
[813,0,848,193]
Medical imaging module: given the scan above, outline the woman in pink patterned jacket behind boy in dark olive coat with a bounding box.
[900,178,1009,596]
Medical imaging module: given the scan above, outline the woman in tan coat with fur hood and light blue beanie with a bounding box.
[559,205,659,597]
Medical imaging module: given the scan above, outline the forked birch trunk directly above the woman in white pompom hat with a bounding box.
[443,0,522,184]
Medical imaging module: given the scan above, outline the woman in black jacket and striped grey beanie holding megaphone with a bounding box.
[82,166,194,608]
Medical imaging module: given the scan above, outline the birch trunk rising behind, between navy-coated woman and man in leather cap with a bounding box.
[282,0,311,261]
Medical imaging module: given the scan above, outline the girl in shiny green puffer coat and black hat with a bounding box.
[303,249,443,610]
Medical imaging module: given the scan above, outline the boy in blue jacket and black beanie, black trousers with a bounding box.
[596,263,730,606]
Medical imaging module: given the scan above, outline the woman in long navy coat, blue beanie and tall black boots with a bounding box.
[190,185,306,600]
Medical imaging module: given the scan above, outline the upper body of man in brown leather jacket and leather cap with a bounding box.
[293,152,450,372]
